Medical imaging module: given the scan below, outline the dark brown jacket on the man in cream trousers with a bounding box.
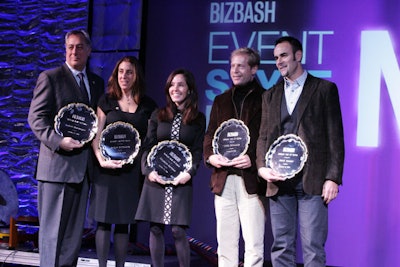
[203,81,266,195]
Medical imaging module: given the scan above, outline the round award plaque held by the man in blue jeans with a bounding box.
[265,134,308,179]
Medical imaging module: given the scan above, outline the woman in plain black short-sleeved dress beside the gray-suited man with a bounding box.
[89,56,157,267]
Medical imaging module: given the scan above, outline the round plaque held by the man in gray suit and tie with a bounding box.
[54,103,97,143]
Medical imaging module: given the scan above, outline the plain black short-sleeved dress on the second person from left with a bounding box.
[89,94,157,224]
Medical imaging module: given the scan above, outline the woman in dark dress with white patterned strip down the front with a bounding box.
[136,69,206,267]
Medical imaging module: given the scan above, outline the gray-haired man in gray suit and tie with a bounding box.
[28,30,104,267]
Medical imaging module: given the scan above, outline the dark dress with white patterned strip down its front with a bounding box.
[135,111,206,226]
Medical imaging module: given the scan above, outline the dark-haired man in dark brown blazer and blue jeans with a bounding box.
[257,36,344,267]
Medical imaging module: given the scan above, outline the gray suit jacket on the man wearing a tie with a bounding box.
[28,63,104,183]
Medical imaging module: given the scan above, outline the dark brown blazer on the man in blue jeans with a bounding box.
[257,74,344,196]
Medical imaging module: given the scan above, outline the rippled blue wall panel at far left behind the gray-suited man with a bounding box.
[0,0,88,223]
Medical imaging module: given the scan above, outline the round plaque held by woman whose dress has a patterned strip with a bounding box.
[147,140,192,182]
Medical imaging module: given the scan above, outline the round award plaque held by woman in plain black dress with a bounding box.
[99,121,141,164]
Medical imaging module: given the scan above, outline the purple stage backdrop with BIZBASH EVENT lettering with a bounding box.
[146,0,400,267]
